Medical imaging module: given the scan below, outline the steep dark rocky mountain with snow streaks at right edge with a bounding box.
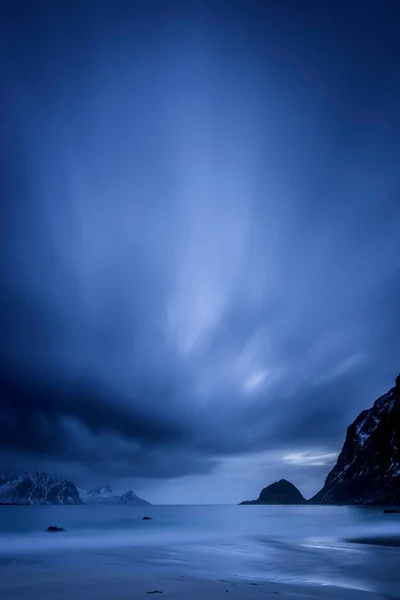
[310,375,400,505]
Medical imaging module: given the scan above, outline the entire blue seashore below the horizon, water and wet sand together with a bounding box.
[0,506,400,600]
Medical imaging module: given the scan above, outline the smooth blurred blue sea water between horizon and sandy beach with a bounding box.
[0,506,400,599]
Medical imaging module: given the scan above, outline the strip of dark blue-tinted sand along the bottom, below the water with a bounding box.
[0,567,384,600]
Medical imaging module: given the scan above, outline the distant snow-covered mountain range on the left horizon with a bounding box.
[0,472,150,506]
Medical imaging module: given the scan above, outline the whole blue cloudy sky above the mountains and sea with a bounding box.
[0,0,400,504]
